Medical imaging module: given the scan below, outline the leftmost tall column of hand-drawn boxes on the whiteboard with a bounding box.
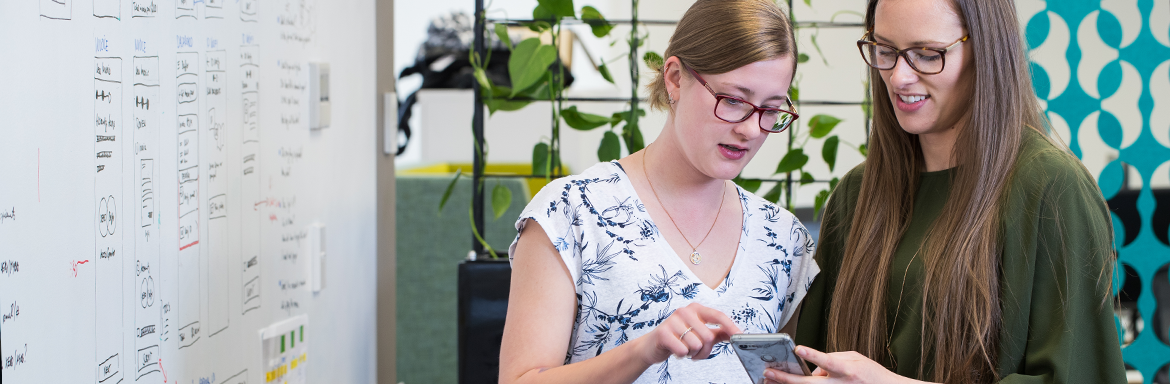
[94,57,125,384]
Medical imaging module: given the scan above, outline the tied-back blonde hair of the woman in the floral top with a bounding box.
[646,0,797,110]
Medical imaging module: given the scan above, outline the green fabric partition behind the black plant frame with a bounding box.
[397,174,529,384]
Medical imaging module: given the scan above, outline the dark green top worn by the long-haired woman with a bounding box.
[797,129,1126,383]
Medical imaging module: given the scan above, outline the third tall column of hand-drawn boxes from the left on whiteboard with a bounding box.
[176,52,202,348]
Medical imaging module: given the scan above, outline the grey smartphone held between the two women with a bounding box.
[731,334,810,384]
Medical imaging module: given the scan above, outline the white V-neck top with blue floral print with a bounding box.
[509,162,820,384]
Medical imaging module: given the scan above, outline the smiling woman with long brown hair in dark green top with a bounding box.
[769,0,1126,383]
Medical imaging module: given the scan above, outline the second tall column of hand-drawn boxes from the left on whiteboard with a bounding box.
[133,54,165,379]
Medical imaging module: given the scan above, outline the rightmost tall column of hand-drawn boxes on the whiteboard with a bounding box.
[240,45,261,314]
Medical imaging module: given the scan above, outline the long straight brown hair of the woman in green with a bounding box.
[827,0,1046,383]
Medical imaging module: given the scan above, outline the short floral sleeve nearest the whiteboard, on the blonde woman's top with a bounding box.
[508,179,581,284]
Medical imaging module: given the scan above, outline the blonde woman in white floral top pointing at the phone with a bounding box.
[500,0,819,384]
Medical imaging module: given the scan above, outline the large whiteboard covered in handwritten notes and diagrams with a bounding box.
[0,0,376,384]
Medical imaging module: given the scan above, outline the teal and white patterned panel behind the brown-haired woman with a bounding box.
[1017,0,1170,383]
